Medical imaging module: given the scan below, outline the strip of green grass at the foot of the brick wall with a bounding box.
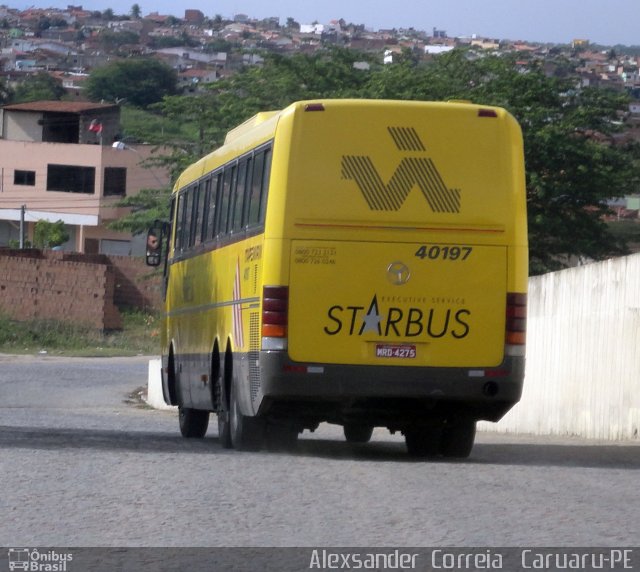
[0,310,160,357]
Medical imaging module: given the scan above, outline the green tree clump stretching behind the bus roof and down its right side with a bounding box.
[119,48,639,273]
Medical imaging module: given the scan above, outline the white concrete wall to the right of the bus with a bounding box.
[479,254,640,440]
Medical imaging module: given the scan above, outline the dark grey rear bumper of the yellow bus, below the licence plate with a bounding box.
[254,352,525,421]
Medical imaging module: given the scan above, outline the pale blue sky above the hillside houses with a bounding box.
[20,0,640,45]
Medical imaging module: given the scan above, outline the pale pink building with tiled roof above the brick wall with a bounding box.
[0,101,169,254]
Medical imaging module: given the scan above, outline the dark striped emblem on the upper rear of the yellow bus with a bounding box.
[342,127,461,213]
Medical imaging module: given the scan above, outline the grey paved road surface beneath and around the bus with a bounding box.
[0,355,640,547]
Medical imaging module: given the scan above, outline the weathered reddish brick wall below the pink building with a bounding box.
[0,249,161,330]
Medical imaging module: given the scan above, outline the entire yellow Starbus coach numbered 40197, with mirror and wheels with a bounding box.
[148,100,528,457]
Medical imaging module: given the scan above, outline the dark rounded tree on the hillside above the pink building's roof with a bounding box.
[86,59,178,108]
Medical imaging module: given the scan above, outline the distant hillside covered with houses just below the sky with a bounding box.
[0,5,640,96]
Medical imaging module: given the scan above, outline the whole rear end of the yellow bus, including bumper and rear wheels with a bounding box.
[253,100,528,457]
